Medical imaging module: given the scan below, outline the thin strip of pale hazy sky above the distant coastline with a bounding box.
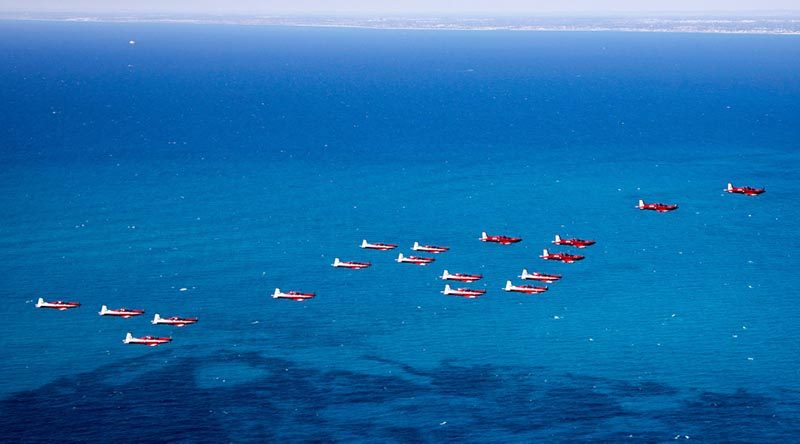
[0,0,800,15]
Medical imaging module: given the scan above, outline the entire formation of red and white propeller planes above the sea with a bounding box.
[35,183,765,347]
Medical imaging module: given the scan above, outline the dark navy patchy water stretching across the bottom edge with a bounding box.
[0,351,800,442]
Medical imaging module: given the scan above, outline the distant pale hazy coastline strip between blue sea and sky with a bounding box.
[0,13,800,35]
